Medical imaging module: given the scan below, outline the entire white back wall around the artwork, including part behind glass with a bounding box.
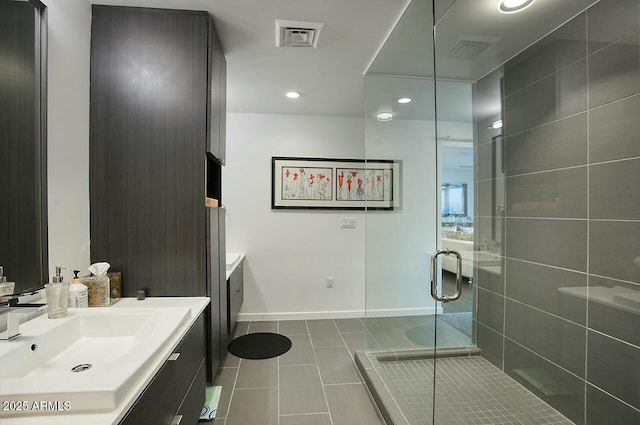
[223,114,470,320]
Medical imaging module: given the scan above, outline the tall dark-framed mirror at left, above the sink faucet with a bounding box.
[0,0,48,292]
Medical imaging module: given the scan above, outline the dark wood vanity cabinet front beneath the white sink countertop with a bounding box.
[120,315,206,425]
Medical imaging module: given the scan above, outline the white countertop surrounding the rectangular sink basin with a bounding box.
[0,297,209,425]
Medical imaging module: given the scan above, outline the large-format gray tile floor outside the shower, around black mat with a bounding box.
[214,319,383,425]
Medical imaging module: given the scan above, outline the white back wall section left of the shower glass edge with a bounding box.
[222,113,364,320]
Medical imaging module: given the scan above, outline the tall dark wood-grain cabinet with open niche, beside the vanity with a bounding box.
[89,6,227,381]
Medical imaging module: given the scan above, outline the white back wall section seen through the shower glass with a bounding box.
[366,119,472,315]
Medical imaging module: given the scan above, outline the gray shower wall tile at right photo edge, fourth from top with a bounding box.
[589,158,640,220]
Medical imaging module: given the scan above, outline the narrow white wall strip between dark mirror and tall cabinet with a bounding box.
[46,0,91,281]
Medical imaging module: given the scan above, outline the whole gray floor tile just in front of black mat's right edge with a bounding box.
[280,364,329,414]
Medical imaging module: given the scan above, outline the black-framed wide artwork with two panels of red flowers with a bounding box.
[271,157,400,210]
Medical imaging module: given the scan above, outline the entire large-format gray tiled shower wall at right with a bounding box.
[475,0,640,425]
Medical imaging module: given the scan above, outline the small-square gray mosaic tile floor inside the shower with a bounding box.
[380,356,573,425]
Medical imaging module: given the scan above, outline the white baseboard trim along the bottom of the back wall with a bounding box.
[238,306,442,322]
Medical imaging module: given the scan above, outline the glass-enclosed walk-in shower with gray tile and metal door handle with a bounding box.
[356,0,640,425]
